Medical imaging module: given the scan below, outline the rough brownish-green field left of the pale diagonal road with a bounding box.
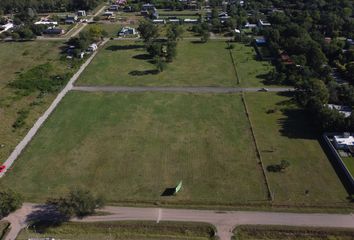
[0,41,72,164]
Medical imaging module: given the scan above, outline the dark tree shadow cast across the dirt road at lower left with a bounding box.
[26,204,69,233]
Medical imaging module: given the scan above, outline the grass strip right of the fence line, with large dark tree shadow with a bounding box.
[246,93,348,205]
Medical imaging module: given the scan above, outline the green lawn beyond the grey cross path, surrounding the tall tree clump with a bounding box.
[77,41,236,86]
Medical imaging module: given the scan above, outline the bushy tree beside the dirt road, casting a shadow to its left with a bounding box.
[47,189,104,218]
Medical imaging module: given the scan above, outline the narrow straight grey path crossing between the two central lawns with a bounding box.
[72,86,295,93]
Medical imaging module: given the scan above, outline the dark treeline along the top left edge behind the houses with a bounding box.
[0,0,102,14]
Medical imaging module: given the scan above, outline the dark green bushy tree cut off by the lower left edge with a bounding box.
[0,189,22,219]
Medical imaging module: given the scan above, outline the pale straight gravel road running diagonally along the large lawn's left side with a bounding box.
[0,40,108,178]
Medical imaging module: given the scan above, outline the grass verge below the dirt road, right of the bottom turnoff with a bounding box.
[234,226,354,240]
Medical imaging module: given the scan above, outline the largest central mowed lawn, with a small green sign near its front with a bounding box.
[0,92,266,204]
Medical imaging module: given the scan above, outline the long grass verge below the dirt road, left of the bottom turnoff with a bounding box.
[17,221,215,240]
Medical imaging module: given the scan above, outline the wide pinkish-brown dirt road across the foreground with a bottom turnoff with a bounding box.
[5,203,354,240]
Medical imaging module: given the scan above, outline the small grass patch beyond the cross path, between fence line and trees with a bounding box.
[232,43,274,87]
